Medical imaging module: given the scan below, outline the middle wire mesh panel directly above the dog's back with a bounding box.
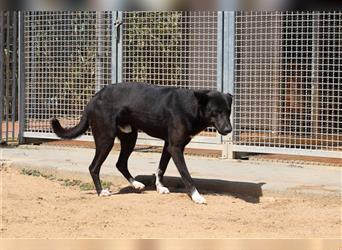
[122,11,217,139]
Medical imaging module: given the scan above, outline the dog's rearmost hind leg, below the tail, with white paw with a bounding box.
[89,134,114,196]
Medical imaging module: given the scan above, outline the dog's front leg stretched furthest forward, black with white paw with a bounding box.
[168,145,207,204]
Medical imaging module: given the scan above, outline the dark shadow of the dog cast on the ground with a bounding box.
[116,175,265,203]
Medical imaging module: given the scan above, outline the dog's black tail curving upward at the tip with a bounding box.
[51,111,89,139]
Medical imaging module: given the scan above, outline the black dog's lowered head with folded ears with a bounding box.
[194,90,233,135]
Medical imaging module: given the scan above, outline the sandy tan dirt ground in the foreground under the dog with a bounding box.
[1,167,342,238]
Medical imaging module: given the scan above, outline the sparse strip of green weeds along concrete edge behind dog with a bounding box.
[20,168,112,191]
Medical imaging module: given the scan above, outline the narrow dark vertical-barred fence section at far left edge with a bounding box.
[0,11,19,144]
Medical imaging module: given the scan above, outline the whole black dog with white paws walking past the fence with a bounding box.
[52,83,232,203]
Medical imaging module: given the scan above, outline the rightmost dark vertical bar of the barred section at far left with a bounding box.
[11,11,18,140]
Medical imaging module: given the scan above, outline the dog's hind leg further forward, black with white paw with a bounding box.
[116,129,145,190]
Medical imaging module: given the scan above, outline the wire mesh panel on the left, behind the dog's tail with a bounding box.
[24,11,112,137]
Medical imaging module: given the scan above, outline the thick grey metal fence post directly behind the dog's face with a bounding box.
[222,11,235,159]
